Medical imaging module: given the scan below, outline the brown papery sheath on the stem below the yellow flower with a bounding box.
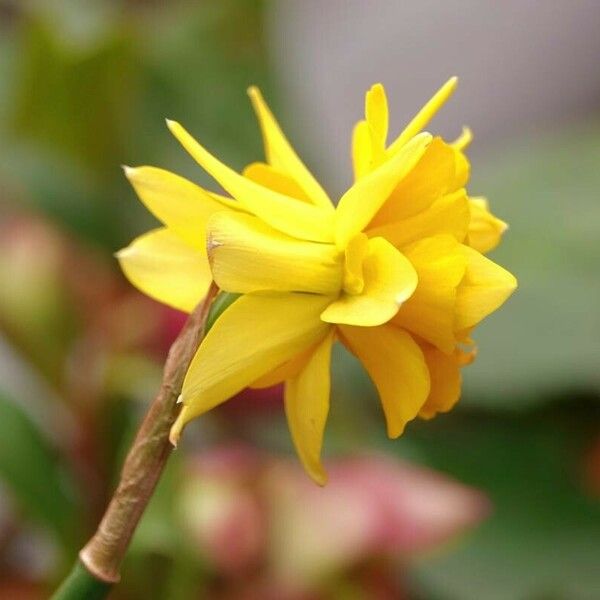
[79,283,218,583]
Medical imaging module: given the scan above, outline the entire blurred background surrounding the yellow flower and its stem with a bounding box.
[0,0,600,600]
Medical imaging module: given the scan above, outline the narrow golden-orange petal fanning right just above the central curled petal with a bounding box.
[369,189,471,248]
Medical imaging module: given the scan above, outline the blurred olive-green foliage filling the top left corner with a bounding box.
[0,0,268,250]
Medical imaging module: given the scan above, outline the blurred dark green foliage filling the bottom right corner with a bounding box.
[410,402,600,600]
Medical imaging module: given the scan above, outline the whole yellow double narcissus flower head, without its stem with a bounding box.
[118,78,516,484]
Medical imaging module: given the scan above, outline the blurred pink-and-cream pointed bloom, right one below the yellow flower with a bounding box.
[269,455,490,580]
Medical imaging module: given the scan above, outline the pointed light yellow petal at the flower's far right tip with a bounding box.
[455,246,517,330]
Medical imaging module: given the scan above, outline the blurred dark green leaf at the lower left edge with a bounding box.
[0,391,81,551]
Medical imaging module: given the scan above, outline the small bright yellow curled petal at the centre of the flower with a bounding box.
[321,238,417,327]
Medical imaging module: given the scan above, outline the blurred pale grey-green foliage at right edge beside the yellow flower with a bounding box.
[465,127,600,409]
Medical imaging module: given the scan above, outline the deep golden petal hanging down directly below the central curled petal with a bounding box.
[340,324,429,438]
